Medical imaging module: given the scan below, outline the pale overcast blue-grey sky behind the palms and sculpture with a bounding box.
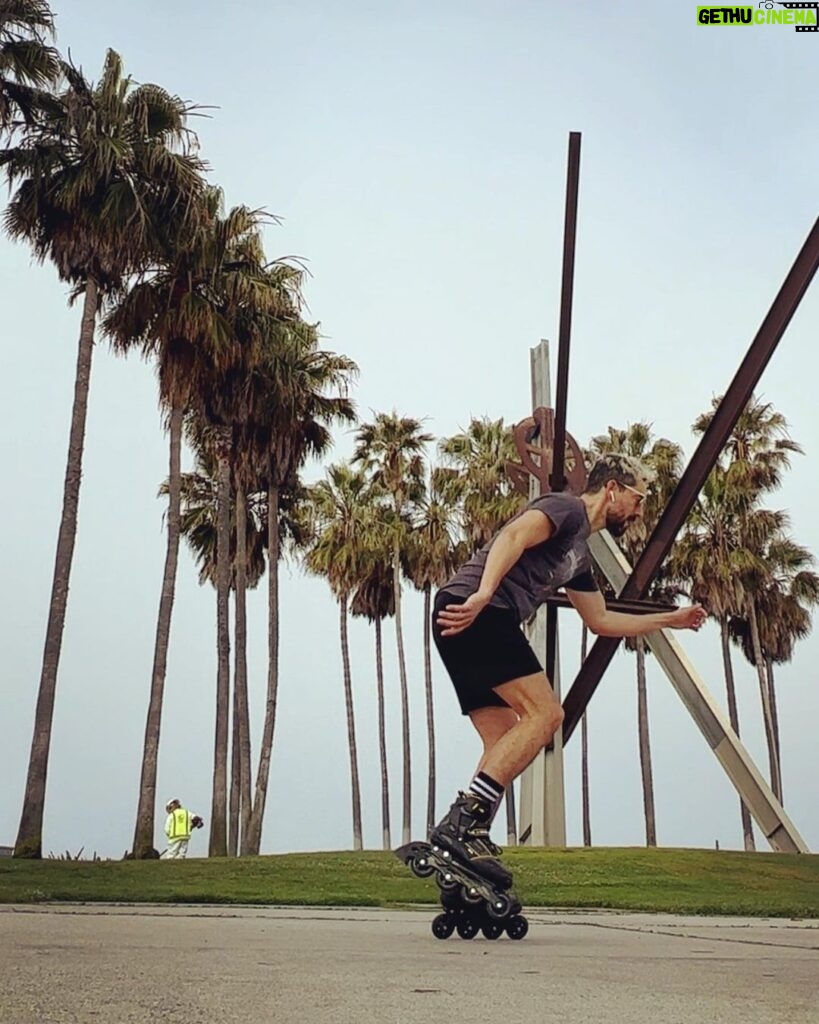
[0,0,819,856]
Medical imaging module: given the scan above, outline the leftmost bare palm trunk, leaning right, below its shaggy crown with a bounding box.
[14,278,98,858]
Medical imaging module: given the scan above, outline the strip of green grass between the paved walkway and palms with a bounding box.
[0,848,819,918]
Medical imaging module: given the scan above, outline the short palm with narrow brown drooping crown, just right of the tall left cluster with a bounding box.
[350,528,395,850]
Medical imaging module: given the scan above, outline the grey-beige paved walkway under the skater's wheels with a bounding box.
[0,905,819,1024]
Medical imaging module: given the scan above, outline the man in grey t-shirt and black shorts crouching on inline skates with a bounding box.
[429,455,705,889]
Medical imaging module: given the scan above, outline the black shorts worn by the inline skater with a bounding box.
[432,590,544,715]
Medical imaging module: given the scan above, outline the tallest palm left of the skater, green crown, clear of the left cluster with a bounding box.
[353,412,432,843]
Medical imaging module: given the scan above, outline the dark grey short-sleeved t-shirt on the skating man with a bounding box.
[441,493,597,622]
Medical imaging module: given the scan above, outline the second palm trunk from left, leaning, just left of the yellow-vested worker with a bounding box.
[133,406,182,858]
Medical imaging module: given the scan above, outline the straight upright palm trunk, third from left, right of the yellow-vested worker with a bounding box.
[208,440,230,857]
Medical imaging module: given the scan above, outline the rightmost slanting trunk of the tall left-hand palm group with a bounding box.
[242,481,278,855]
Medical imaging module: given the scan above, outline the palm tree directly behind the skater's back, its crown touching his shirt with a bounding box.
[407,468,466,833]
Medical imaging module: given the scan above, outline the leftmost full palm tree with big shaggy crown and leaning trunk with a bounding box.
[7,50,202,857]
